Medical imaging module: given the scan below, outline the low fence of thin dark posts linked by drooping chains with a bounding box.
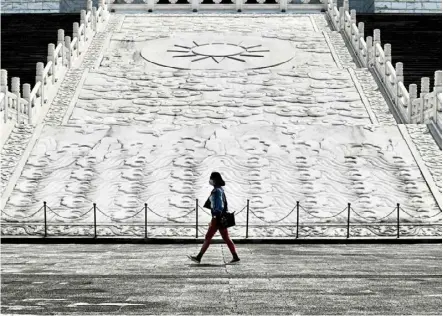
[1,199,442,239]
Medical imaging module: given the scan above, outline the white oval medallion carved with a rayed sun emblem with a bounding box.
[141,33,295,70]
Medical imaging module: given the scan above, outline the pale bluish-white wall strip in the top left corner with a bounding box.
[1,0,60,13]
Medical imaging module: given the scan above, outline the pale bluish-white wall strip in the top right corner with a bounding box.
[375,0,441,13]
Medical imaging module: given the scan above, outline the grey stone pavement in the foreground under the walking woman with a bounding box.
[1,244,442,315]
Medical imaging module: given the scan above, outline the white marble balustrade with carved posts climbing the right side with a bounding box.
[328,0,442,134]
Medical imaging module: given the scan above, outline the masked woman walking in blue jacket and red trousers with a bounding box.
[189,172,240,263]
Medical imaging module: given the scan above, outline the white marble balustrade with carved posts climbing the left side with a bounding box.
[0,0,108,126]
